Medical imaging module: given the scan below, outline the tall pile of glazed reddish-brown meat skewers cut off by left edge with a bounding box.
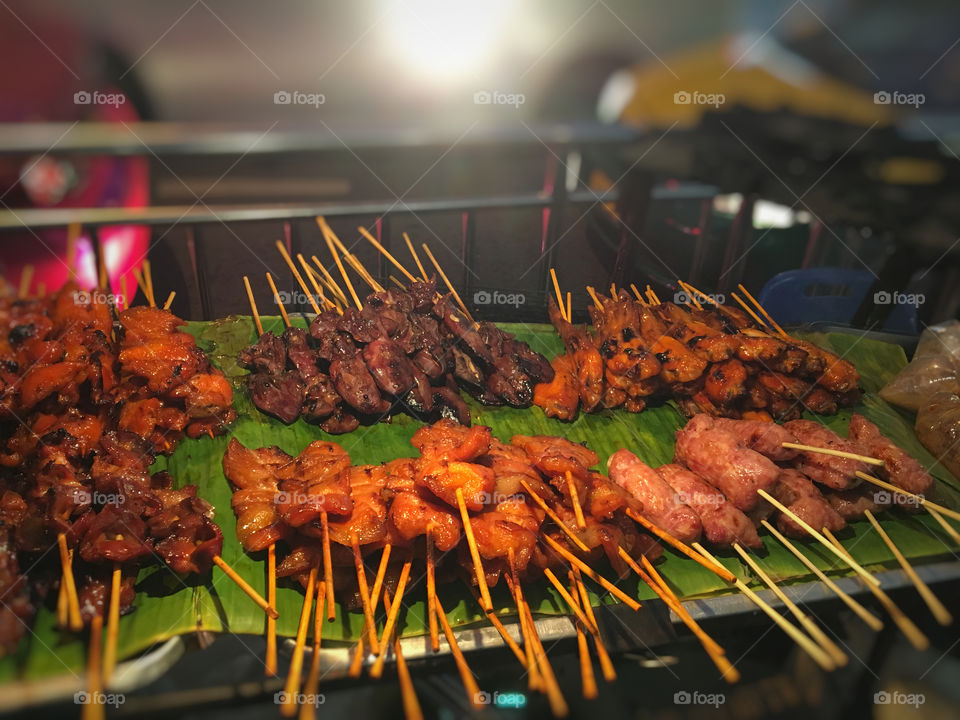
[0,255,274,710]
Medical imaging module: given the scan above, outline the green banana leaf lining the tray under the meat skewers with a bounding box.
[0,317,960,679]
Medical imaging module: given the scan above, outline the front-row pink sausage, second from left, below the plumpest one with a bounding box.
[657,464,763,548]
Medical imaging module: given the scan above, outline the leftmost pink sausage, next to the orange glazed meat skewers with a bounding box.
[607,450,703,542]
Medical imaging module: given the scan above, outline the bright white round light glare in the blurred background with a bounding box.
[390,0,507,80]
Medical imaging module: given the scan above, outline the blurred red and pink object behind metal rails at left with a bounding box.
[0,3,150,295]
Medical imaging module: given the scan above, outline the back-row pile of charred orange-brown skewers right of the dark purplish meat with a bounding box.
[534,273,860,420]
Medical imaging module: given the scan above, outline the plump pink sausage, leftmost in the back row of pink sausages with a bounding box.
[674,414,780,512]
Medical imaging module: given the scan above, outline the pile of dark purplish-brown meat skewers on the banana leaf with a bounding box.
[240,218,553,434]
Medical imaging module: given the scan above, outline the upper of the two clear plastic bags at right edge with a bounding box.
[880,320,960,410]
